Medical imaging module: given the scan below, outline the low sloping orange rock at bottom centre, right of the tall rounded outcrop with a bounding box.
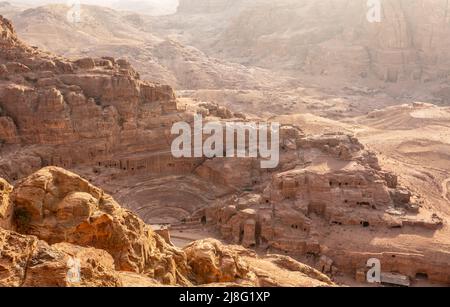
[183,239,334,287]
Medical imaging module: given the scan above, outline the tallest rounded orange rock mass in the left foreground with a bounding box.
[13,167,187,284]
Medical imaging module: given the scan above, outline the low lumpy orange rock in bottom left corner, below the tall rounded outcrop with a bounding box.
[0,228,121,287]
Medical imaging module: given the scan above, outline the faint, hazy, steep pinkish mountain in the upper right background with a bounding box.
[167,0,450,87]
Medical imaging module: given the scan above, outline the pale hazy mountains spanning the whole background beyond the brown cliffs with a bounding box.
[2,0,450,115]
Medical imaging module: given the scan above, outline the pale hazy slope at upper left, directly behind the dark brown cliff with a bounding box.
[0,5,278,89]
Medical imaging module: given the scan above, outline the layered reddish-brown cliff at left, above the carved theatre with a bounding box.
[0,14,182,181]
